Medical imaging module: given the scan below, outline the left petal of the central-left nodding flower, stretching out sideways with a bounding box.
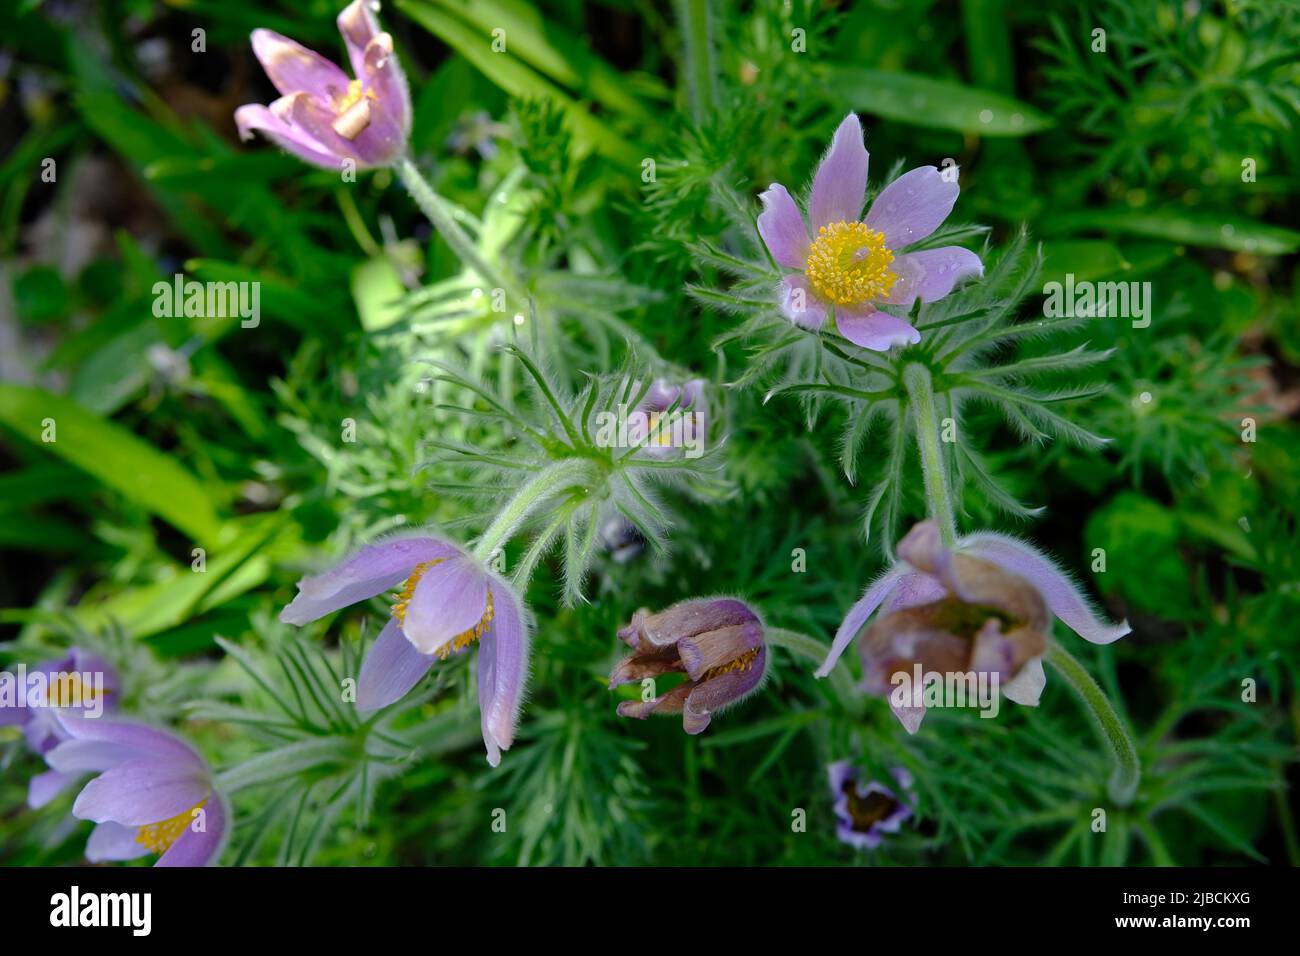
[280,537,460,624]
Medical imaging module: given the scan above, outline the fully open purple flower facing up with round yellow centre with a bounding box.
[758,113,984,351]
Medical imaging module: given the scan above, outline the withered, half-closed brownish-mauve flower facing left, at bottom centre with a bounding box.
[610,597,767,734]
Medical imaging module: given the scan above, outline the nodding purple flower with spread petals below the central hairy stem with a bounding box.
[280,537,529,766]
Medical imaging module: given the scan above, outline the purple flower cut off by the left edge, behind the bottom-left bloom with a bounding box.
[0,648,122,809]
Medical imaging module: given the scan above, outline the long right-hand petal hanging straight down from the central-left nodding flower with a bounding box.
[478,576,529,766]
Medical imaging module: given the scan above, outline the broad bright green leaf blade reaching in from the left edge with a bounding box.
[0,384,220,540]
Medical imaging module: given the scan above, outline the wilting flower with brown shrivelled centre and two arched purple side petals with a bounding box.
[816,519,1131,734]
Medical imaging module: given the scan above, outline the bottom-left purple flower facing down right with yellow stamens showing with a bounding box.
[46,711,230,866]
